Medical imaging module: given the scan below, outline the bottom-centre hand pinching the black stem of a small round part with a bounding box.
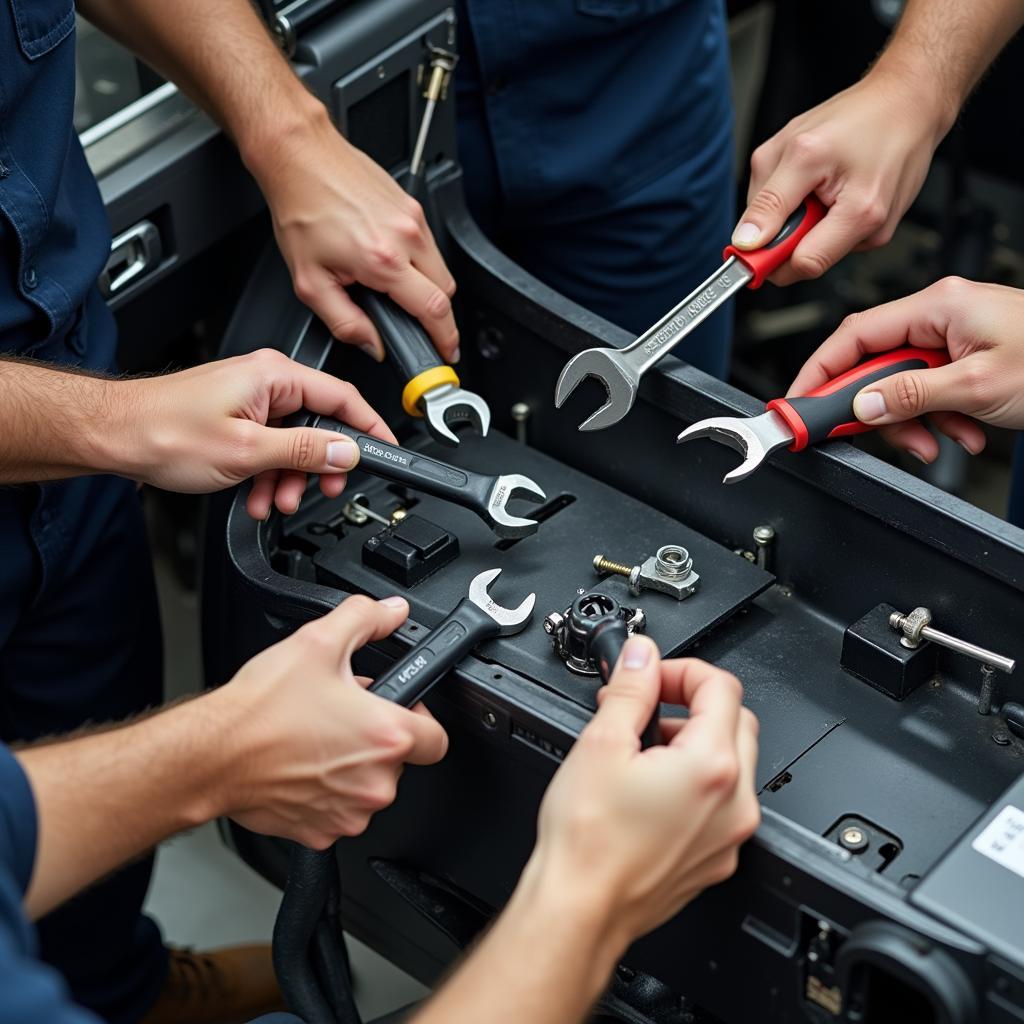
[524,637,761,942]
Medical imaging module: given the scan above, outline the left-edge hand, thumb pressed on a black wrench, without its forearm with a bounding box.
[113,349,395,519]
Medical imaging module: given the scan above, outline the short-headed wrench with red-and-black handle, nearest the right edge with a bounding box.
[677,345,949,483]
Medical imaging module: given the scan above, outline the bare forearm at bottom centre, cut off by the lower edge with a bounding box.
[413,858,628,1024]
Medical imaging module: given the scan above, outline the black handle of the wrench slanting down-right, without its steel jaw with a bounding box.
[312,416,498,512]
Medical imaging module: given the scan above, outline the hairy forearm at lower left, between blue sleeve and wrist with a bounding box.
[15,694,230,919]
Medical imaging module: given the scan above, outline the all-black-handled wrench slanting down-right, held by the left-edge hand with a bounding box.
[310,416,547,539]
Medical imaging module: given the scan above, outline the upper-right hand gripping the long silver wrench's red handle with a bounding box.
[732,70,949,285]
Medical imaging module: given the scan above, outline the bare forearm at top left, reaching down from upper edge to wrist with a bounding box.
[78,0,333,177]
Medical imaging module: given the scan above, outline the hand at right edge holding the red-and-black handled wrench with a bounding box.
[790,278,1024,462]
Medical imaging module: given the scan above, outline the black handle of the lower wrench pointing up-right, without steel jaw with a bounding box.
[370,597,498,708]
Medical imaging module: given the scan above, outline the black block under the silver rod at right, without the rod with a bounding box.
[840,604,935,700]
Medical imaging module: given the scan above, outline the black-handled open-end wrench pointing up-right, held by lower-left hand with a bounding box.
[370,569,537,708]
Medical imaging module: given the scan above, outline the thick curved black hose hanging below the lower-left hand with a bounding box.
[272,846,342,1024]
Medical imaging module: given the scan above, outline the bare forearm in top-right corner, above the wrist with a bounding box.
[872,0,1024,130]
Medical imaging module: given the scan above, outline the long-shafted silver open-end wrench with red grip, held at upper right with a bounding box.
[555,195,825,430]
